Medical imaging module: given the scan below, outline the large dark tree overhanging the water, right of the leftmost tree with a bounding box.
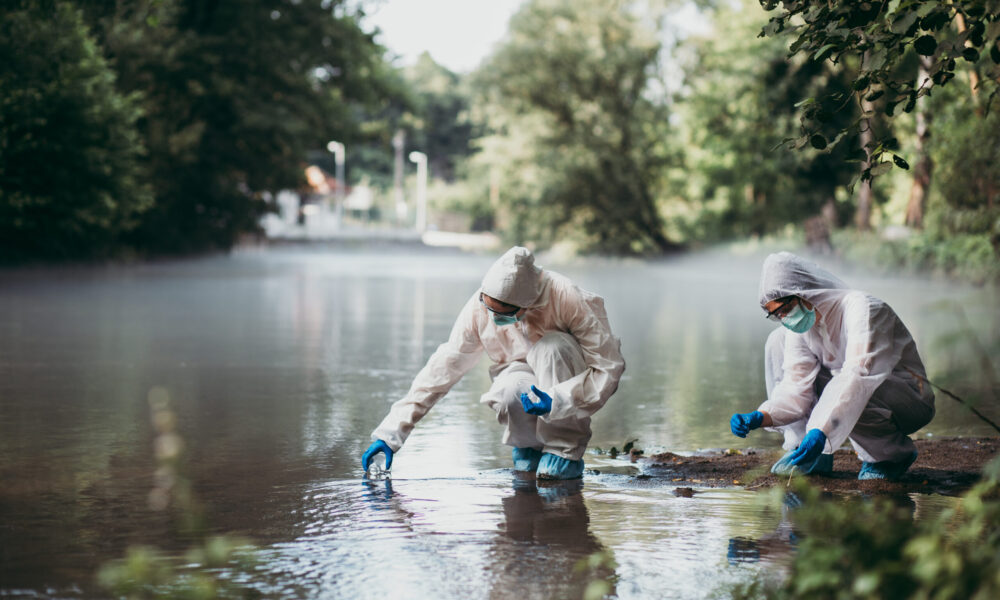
[80,0,392,252]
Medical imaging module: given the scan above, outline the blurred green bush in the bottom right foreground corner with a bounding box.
[733,459,1000,600]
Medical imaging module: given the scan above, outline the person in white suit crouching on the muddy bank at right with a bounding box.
[730,252,934,479]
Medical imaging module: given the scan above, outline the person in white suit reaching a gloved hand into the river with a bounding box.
[361,246,625,479]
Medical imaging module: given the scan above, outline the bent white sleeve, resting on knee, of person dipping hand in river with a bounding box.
[542,286,625,420]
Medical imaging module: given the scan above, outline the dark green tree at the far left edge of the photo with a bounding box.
[0,2,150,261]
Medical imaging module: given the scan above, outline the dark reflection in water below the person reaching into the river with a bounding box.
[490,477,614,600]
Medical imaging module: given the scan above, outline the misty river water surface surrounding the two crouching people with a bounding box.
[0,247,1000,598]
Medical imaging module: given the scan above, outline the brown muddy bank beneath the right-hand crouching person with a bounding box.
[632,438,1000,495]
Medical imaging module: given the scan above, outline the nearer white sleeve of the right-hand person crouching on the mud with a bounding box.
[806,293,902,450]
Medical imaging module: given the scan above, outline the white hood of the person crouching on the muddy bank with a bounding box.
[760,252,850,312]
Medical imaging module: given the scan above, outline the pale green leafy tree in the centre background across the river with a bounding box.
[475,0,675,253]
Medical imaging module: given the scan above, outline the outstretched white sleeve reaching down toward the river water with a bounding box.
[372,293,483,452]
